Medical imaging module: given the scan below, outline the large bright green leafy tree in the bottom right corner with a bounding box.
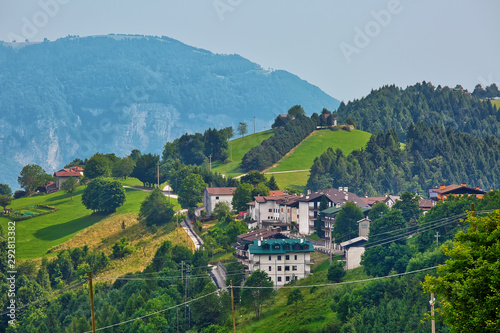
[423,210,500,332]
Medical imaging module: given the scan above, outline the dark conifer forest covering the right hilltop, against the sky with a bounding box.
[337,81,500,141]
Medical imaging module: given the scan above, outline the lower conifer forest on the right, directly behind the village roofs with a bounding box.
[307,123,500,196]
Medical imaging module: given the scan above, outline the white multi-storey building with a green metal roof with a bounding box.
[248,239,314,288]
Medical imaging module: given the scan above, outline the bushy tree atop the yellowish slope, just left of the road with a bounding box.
[139,188,174,226]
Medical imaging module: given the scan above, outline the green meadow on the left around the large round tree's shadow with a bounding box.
[0,180,176,260]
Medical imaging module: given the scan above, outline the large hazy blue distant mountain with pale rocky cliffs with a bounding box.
[0,35,339,188]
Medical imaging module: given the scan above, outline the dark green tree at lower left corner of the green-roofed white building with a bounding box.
[241,269,274,318]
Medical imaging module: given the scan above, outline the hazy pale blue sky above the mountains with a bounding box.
[0,0,500,101]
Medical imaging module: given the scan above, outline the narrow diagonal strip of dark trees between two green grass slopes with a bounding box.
[241,114,316,171]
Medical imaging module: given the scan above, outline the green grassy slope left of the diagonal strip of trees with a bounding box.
[212,130,274,177]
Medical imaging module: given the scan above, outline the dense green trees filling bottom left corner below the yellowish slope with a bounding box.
[0,241,230,333]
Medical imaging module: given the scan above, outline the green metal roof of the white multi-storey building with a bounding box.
[248,239,314,254]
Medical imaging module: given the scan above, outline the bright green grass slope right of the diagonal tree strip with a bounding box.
[268,130,371,172]
